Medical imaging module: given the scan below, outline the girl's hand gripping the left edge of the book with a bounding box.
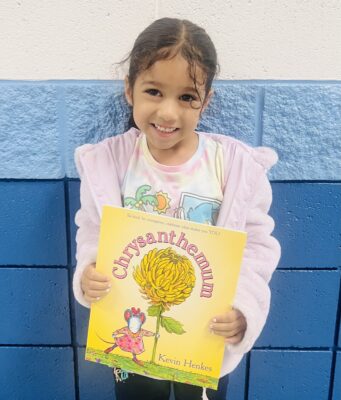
[81,264,111,303]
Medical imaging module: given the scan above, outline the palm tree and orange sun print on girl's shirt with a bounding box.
[123,185,171,214]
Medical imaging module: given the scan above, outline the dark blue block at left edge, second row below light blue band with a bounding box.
[0,268,71,345]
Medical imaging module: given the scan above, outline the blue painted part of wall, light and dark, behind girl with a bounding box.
[0,81,341,400]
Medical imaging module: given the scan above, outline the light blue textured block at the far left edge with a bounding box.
[0,83,64,179]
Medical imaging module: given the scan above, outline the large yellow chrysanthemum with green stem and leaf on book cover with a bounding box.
[133,247,195,363]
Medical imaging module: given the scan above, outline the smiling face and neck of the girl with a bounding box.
[125,55,211,165]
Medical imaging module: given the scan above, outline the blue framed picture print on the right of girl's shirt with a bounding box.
[174,192,221,225]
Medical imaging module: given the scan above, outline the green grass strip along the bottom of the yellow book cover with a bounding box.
[85,347,218,389]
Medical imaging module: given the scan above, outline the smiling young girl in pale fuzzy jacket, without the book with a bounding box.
[74,18,280,400]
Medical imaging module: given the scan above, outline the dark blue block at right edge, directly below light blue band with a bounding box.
[271,183,341,268]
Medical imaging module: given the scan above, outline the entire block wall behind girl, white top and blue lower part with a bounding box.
[0,0,341,400]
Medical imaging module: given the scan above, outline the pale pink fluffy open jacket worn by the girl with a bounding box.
[73,128,280,376]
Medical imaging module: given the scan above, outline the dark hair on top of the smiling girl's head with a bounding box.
[122,18,219,103]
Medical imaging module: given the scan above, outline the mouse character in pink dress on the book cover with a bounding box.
[102,307,155,365]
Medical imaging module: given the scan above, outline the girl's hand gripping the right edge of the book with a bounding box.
[210,309,247,344]
